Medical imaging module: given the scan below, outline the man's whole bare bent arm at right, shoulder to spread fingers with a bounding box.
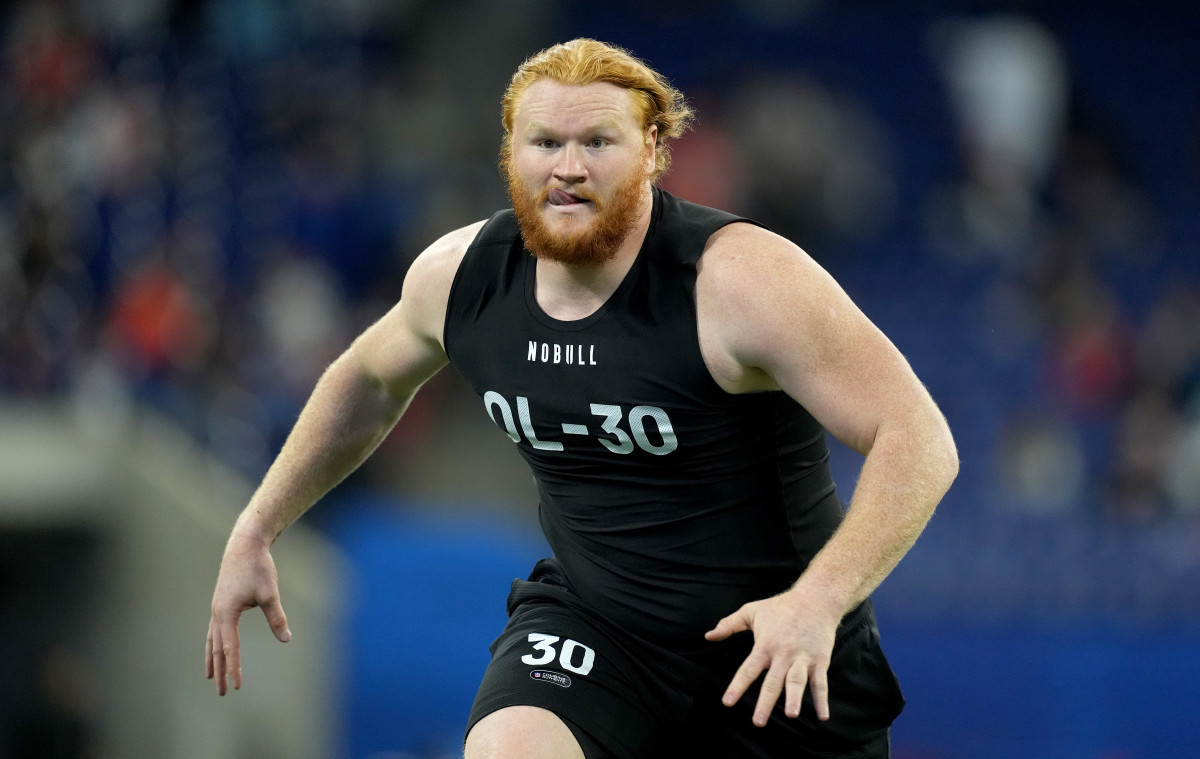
[696,225,958,718]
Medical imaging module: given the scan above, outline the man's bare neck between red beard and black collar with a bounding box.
[535,185,654,321]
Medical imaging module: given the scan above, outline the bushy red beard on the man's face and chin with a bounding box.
[503,156,647,267]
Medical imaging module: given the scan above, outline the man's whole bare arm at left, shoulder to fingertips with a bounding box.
[205,217,482,694]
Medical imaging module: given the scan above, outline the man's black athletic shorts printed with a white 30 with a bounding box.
[467,560,904,759]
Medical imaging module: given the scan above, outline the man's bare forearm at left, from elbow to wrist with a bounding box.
[230,349,410,545]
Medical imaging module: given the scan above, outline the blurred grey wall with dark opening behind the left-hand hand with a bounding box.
[0,406,344,759]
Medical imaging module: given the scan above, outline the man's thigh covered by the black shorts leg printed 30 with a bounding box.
[468,602,661,759]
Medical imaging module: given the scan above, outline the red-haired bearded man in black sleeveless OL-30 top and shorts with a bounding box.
[205,40,958,759]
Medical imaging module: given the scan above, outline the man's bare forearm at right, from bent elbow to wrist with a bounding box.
[797,416,958,616]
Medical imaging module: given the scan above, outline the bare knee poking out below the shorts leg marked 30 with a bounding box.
[464,706,583,759]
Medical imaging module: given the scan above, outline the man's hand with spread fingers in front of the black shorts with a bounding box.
[704,588,841,728]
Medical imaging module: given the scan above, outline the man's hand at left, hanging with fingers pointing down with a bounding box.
[204,538,292,695]
